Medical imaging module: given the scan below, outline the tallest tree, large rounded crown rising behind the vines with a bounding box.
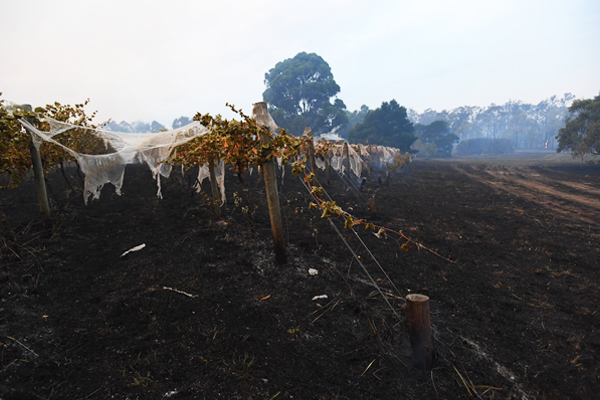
[263,52,348,136]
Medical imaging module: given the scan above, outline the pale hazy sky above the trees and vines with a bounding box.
[0,0,600,127]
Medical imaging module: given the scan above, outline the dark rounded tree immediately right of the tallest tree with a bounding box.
[348,100,417,152]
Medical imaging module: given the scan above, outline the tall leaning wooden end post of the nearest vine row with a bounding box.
[252,101,287,265]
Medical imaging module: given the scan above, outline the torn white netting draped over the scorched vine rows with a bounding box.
[20,114,406,204]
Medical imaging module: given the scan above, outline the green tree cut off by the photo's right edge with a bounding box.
[556,94,600,160]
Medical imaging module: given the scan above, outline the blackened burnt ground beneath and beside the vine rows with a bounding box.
[0,155,600,400]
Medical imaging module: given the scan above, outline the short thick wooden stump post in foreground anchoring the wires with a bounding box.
[406,294,433,370]
